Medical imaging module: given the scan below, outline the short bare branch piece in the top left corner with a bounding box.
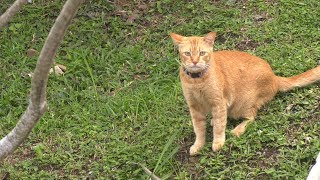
[0,0,28,28]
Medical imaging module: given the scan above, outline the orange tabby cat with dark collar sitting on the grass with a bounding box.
[170,32,320,155]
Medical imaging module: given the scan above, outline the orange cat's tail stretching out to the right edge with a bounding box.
[277,66,320,92]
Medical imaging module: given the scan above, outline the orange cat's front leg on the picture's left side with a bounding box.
[189,106,206,156]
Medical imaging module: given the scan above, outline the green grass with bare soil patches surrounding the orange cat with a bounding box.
[0,0,320,179]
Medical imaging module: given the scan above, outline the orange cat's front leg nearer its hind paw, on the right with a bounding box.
[211,104,227,151]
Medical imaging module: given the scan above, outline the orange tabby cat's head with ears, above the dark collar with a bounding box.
[170,32,216,73]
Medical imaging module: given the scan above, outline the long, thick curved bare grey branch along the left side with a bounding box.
[0,0,84,161]
